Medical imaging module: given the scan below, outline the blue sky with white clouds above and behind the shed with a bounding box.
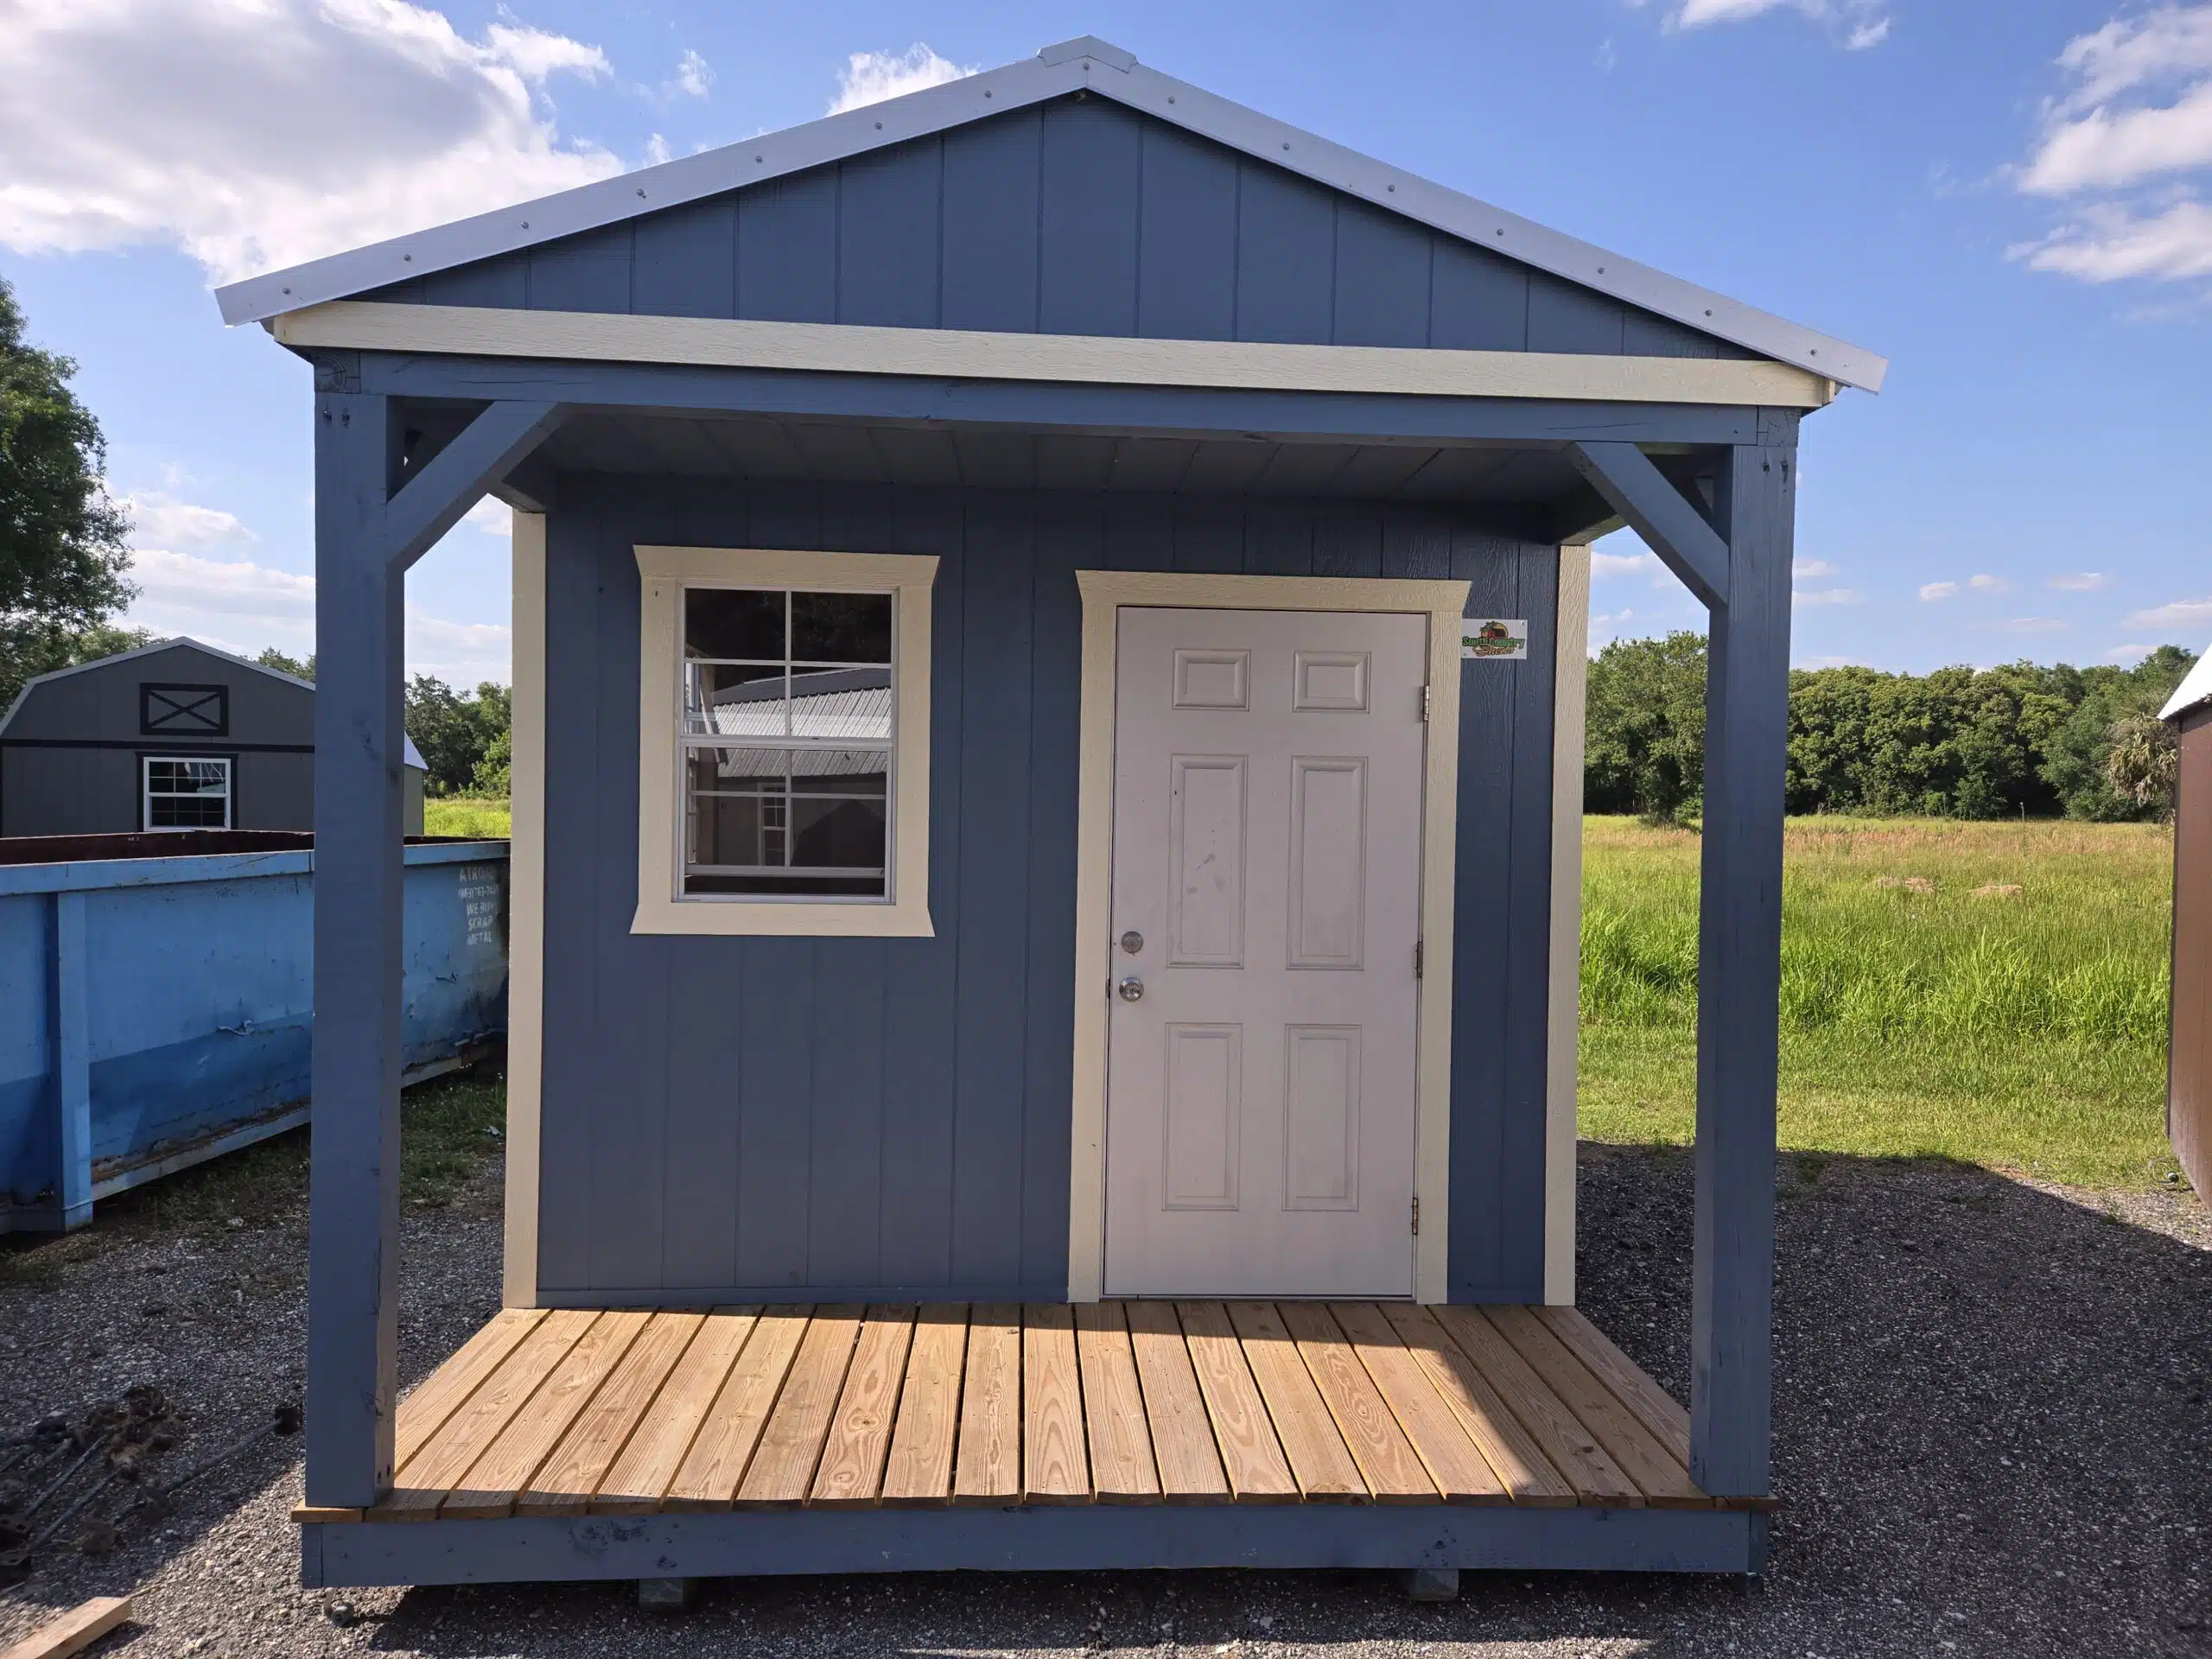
[0,0,2212,681]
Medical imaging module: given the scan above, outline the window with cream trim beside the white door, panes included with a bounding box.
[632,546,936,936]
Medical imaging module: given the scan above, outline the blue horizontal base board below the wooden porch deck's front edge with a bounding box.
[301,1504,1767,1588]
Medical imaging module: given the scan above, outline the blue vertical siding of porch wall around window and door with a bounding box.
[540,475,1557,1303]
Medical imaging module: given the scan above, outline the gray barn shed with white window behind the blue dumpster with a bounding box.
[0,637,425,836]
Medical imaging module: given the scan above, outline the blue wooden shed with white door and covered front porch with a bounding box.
[219,40,1885,1584]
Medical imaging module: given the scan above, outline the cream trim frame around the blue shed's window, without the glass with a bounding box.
[631,546,938,938]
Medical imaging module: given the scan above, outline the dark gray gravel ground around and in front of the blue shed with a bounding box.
[0,1146,2212,1659]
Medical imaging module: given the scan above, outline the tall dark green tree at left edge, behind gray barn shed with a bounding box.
[0,279,133,708]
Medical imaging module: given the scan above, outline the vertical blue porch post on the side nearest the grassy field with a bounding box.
[1690,410,1796,1497]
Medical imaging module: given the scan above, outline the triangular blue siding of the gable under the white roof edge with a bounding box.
[370,98,1754,356]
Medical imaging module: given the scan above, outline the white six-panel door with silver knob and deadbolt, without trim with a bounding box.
[1106,606,1429,1296]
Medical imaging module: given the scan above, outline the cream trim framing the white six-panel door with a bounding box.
[1068,570,1469,1303]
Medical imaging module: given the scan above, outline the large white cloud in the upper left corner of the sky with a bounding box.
[0,0,621,281]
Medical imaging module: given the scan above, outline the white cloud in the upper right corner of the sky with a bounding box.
[2008,3,2212,283]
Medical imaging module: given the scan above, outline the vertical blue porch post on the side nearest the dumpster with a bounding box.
[308,387,404,1509]
